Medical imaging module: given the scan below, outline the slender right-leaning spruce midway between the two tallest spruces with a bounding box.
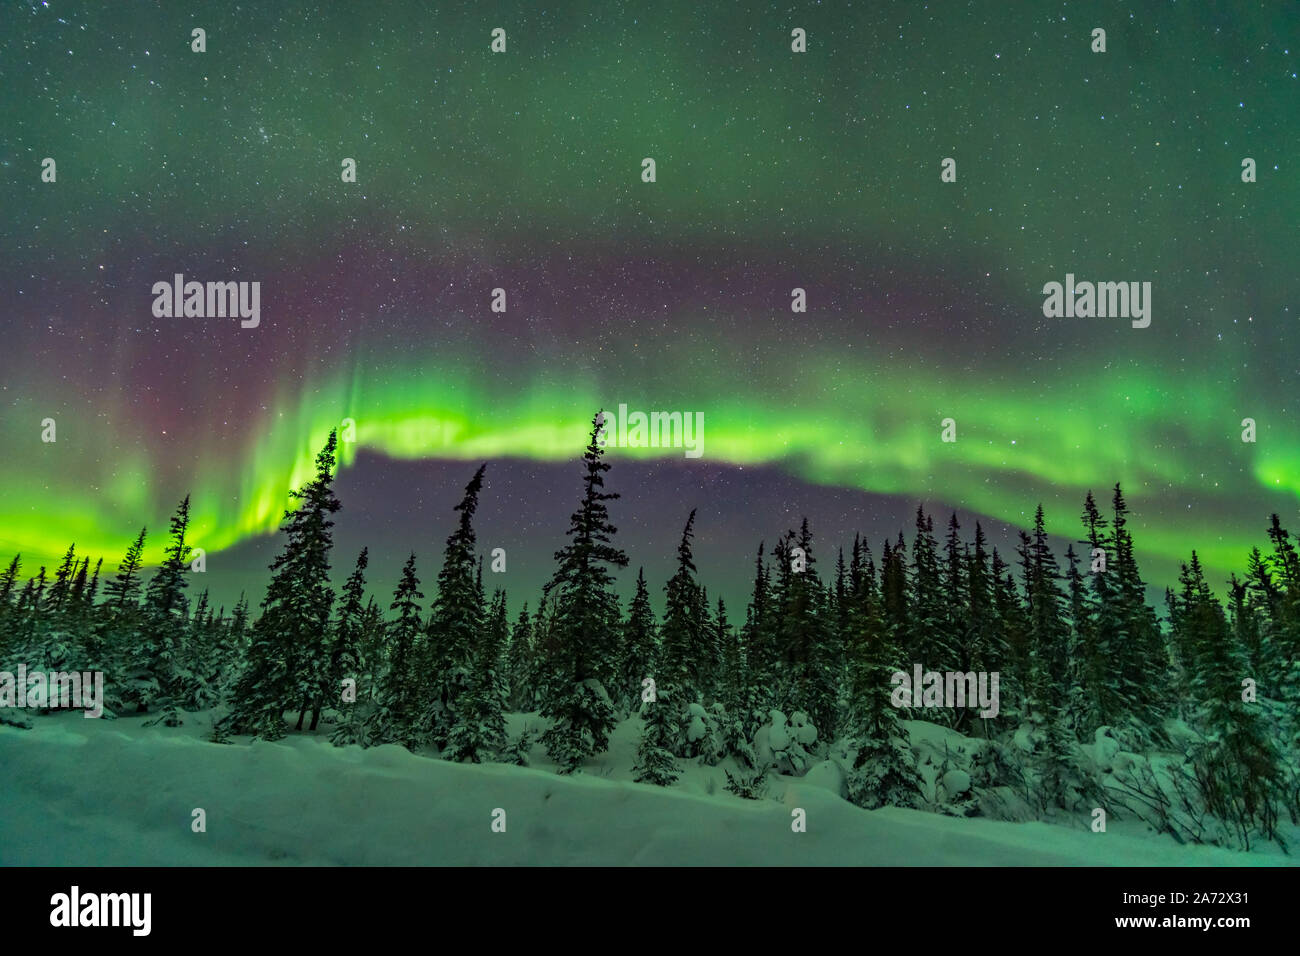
[416,464,488,750]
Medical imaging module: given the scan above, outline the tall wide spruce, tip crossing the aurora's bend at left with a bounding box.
[217,431,341,740]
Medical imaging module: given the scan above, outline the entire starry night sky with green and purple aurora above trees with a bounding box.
[0,0,1300,615]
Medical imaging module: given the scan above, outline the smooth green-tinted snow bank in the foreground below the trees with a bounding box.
[0,713,1292,866]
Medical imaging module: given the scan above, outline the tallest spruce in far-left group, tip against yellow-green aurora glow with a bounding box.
[127,494,191,727]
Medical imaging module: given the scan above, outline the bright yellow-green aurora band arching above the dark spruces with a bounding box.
[0,332,1300,595]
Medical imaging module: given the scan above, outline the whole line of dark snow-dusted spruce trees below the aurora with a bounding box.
[0,415,1300,845]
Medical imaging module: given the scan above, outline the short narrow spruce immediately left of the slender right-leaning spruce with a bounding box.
[364,551,424,750]
